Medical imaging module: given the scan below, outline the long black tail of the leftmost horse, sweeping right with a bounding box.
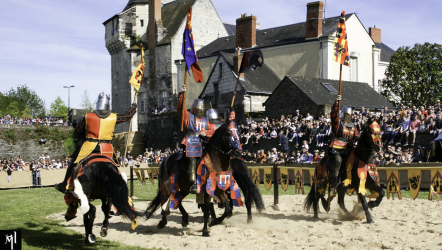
[95,163,139,220]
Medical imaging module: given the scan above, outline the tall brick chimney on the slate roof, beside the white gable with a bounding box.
[305,1,324,39]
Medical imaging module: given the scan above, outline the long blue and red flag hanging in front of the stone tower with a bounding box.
[181,7,203,82]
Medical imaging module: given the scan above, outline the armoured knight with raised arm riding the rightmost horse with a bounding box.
[330,95,360,187]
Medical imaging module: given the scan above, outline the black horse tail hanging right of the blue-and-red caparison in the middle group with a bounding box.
[230,158,265,212]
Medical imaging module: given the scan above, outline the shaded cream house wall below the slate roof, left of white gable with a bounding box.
[261,42,320,79]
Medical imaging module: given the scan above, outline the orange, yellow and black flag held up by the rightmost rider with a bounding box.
[333,11,350,66]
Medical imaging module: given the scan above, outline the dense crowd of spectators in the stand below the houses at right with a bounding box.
[238,100,442,165]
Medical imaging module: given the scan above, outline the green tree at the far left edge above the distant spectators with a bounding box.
[0,85,45,117]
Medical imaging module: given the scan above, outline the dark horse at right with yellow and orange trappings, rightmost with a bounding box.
[304,121,385,223]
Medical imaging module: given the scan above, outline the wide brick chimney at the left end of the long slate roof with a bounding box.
[236,14,256,49]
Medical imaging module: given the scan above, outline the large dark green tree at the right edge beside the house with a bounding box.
[382,43,442,107]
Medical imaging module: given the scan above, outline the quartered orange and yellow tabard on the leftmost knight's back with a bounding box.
[75,113,117,163]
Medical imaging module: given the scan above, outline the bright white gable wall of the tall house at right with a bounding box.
[324,15,374,84]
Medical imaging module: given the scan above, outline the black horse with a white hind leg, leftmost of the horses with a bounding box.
[65,154,138,244]
